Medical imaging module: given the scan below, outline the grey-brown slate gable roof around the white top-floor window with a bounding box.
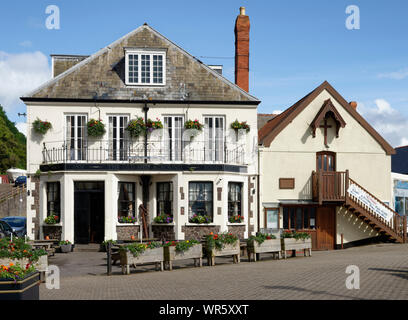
[22,24,260,105]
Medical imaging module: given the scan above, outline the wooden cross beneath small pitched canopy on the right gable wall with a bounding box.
[310,99,346,147]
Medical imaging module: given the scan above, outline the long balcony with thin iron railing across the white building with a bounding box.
[42,140,247,166]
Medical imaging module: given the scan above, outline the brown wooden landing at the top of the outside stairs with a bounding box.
[312,171,349,204]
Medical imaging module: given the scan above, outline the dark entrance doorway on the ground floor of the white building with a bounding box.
[74,182,105,243]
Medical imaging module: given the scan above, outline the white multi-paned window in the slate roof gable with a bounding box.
[126,49,166,86]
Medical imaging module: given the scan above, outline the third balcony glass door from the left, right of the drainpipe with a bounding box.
[164,116,184,161]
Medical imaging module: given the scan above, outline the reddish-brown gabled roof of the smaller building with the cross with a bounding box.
[258,81,395,155]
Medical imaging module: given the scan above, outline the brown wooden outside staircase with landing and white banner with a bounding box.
[312,170,407,243]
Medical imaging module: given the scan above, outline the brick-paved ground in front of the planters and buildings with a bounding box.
[40,244,408,300]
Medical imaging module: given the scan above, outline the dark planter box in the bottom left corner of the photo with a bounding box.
[0,272,40,301]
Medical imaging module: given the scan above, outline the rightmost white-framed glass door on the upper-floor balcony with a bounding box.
[204,116,225,162]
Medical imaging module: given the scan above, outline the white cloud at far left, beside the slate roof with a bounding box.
[0,51,51,111]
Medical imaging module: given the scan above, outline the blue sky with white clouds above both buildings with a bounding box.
[0,0,408,147]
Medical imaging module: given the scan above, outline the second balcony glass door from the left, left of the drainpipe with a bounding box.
[109,115,129,161]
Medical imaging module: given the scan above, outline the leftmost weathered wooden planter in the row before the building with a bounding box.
[120,247,164,274]
